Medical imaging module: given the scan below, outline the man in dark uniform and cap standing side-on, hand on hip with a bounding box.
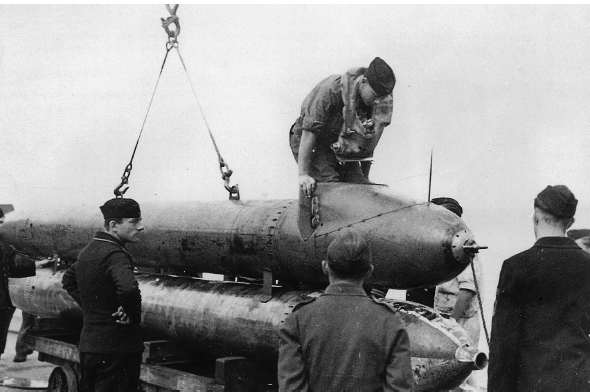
[62,198,144,392]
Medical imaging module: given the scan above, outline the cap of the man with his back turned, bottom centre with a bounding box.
[327,228,373,276]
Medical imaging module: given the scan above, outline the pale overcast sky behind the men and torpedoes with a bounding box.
[0,4,590,350]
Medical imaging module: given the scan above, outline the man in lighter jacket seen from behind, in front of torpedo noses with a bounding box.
[278,228,414,391]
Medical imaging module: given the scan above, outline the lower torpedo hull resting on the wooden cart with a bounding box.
[10,269,487,389]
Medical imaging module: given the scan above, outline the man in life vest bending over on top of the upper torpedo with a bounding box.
[289,57,395,197]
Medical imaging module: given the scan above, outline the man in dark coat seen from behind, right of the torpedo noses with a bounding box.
[488,185,590,392]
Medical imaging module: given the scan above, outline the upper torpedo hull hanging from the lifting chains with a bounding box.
[0,183,473,289]
